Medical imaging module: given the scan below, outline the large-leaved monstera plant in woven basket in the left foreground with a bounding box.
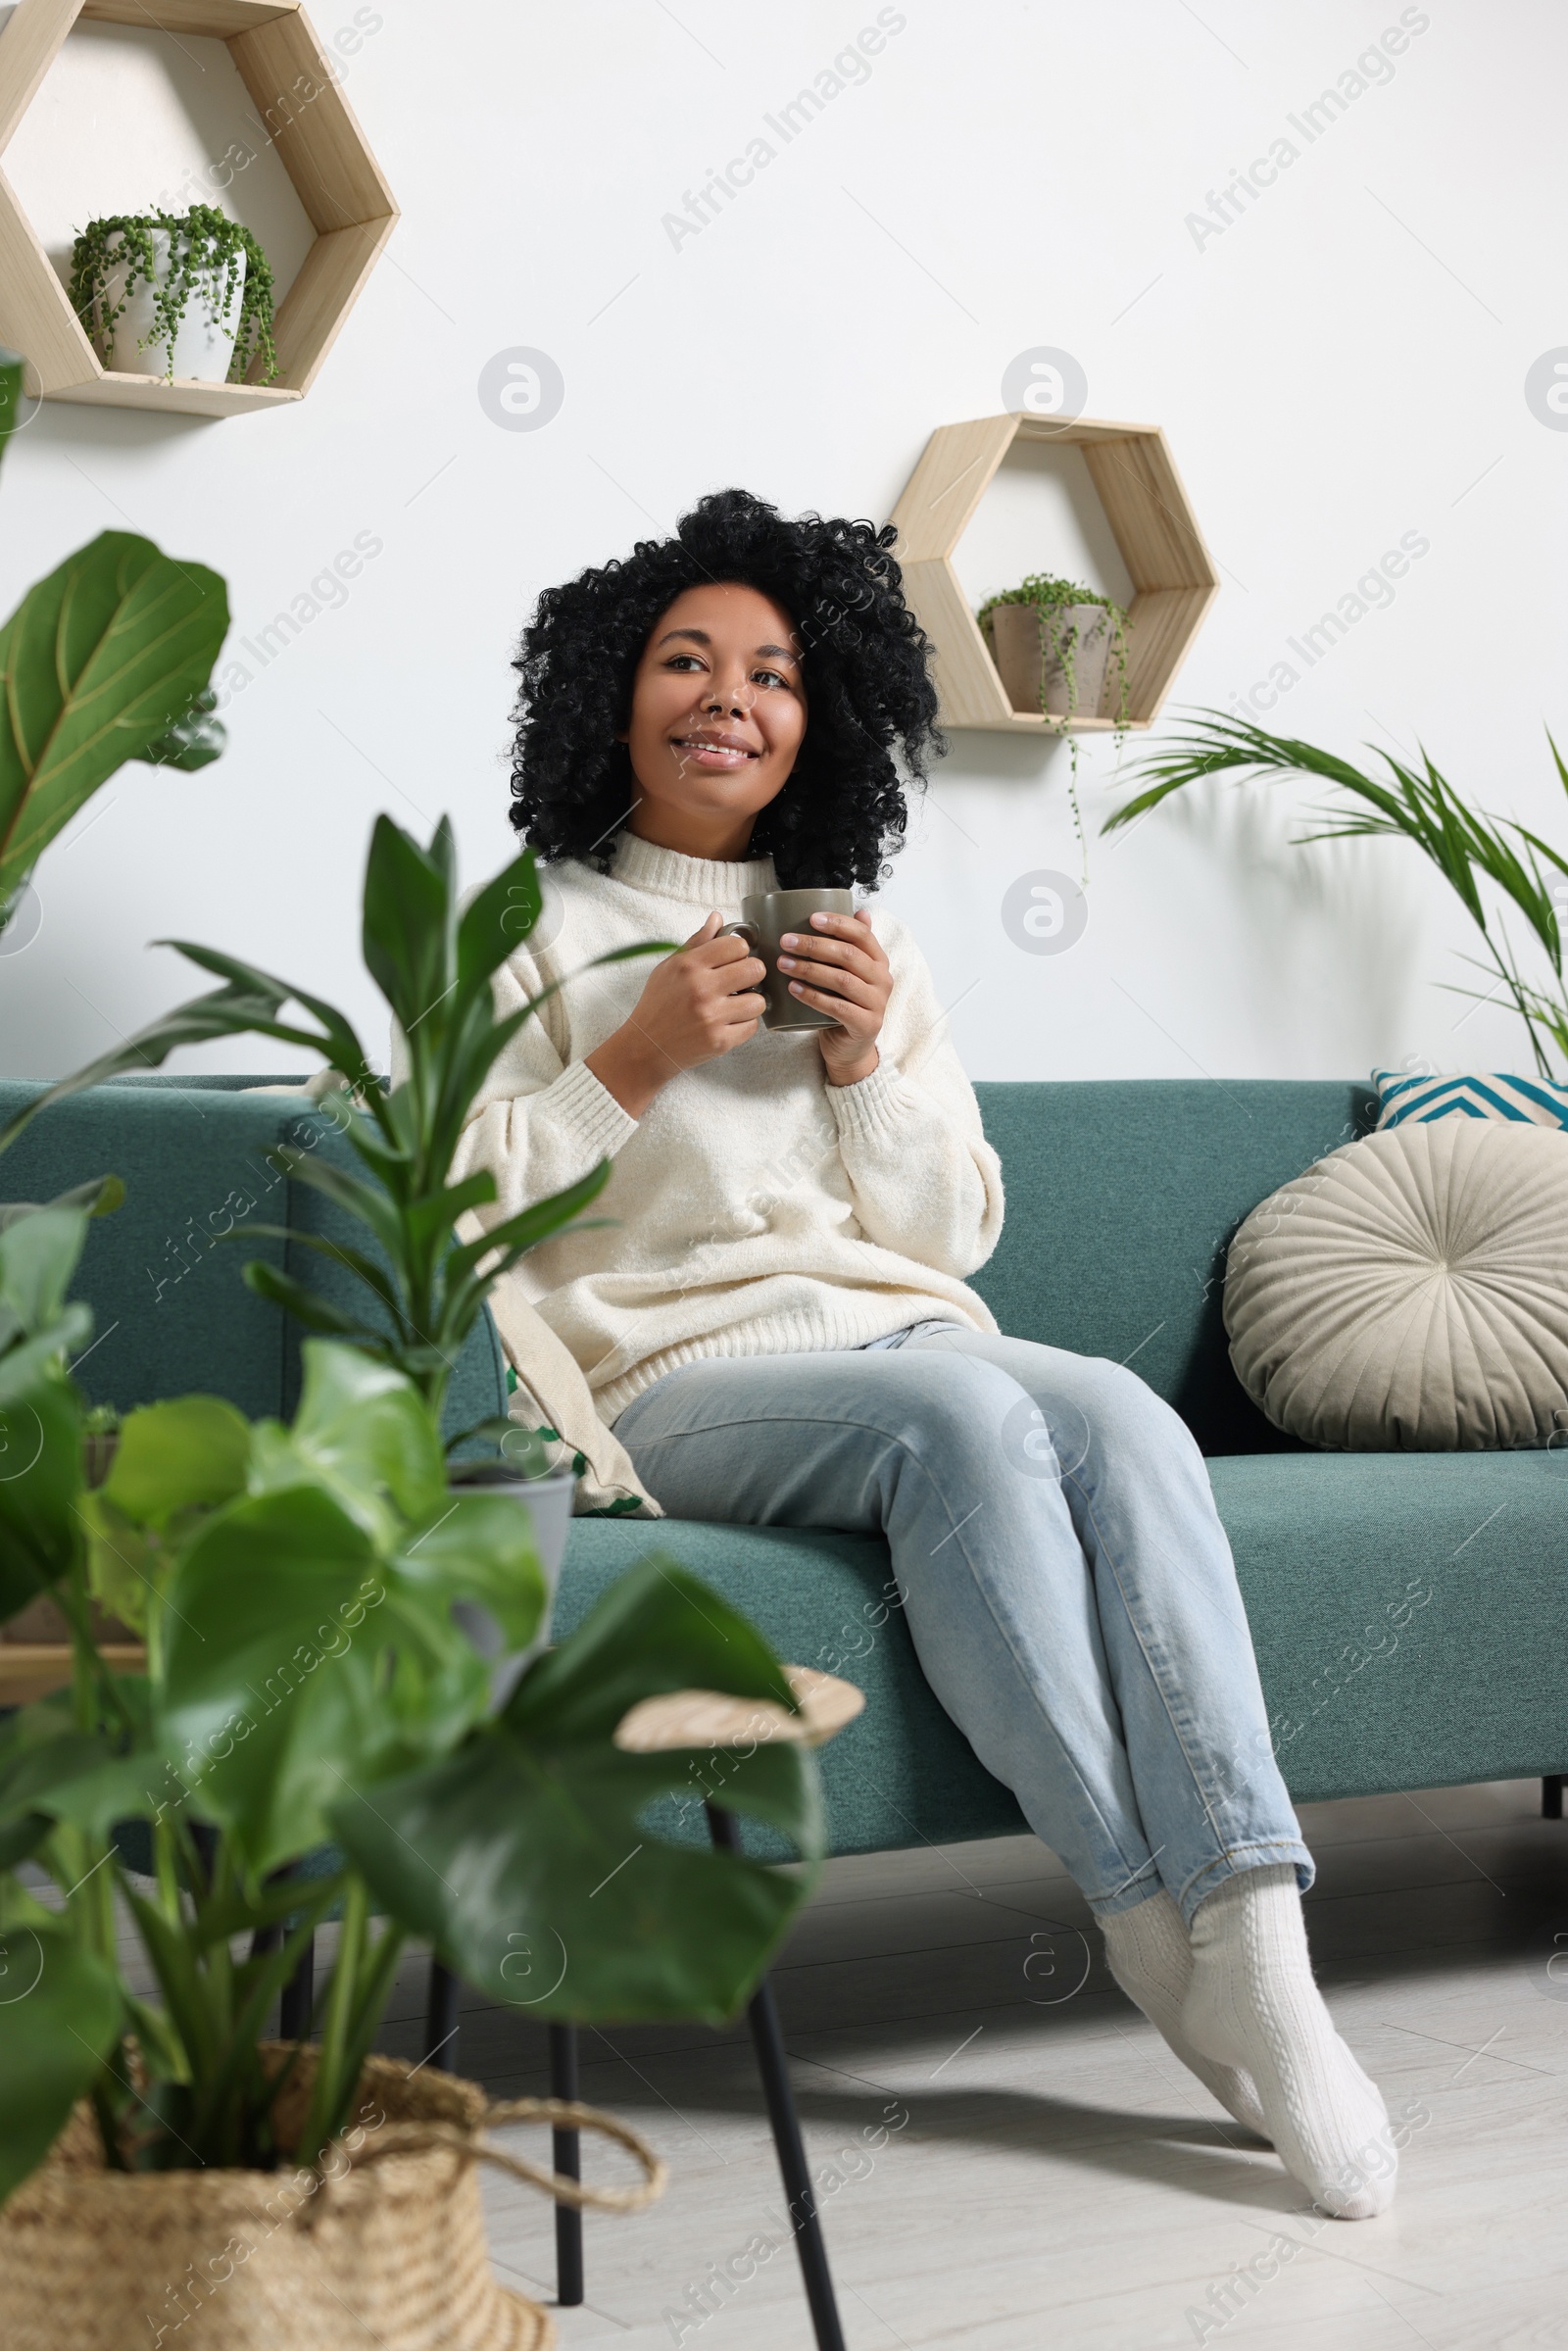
[0,1151,820,2351]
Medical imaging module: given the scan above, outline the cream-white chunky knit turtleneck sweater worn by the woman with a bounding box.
[454,832,1002,1422]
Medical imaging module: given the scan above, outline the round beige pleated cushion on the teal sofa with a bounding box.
[1225,1117,1568,1453]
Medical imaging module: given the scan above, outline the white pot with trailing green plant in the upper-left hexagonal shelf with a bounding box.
[71,205,277,383]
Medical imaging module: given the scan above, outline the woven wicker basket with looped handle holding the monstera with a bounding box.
[0,2048,665,2351]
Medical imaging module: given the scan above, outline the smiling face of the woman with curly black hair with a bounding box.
[620,581,807,860]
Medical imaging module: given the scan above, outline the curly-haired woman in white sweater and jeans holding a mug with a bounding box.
[464,491,1394,2220]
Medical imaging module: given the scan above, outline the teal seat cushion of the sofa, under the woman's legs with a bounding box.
[555,1450,1568,1852]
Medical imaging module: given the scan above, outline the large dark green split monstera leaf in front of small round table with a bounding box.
[331,1556,823,2025]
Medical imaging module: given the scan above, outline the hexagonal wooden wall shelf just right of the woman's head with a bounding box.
[894,414,1220,733]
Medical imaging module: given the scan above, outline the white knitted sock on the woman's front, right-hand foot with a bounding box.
[1183,1862,1398,2220]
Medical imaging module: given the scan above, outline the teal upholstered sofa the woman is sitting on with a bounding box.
[0,1077,1568,1852]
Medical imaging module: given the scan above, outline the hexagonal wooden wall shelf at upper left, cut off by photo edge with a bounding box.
[0,0,397,416]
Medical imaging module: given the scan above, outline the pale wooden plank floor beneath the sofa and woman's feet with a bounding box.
[355,1782,1568,2351]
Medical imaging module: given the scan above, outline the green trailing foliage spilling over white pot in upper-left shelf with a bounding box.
[71,205,277,383]
